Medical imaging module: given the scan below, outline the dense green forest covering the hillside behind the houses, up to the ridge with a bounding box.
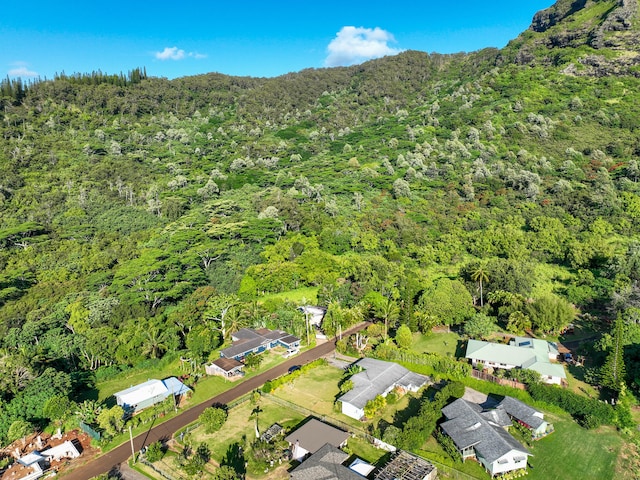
[0,0,640,444]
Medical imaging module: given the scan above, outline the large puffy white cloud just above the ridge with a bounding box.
[324,26,401,67]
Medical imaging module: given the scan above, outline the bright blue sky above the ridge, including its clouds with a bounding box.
[0,0,554,79]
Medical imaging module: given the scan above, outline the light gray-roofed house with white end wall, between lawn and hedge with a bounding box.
[338,358,429,420]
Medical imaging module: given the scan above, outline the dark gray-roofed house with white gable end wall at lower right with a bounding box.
[440,398,531,477]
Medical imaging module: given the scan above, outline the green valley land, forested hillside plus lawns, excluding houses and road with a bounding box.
[0,0,640,480]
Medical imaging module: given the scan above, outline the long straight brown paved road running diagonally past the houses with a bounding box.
[61,323,368,480]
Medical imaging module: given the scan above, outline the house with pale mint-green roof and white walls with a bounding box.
[465,337,567,385]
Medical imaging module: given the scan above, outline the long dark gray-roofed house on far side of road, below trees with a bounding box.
[220,328,300,362]
